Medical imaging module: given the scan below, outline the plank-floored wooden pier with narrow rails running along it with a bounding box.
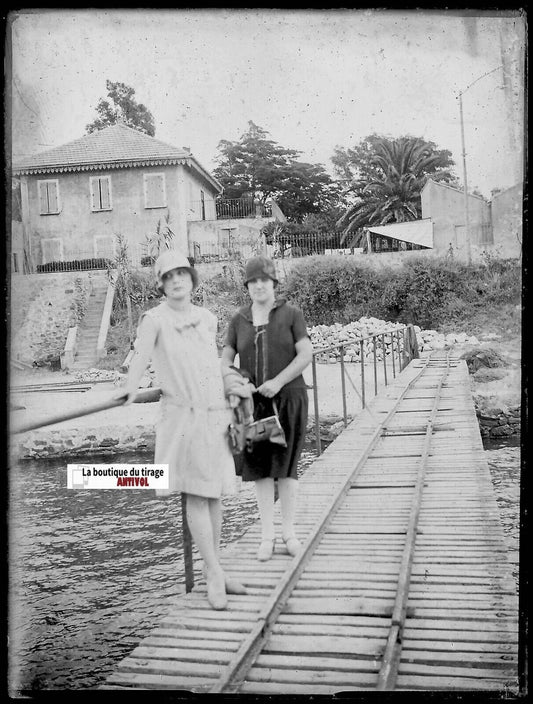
[101,353,518,695]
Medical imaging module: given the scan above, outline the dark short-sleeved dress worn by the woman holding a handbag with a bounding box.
[226,299,308,481]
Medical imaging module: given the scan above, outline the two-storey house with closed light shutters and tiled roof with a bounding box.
[13,124,274,270]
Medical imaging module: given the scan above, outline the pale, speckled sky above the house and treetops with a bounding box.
[6,9,525,197]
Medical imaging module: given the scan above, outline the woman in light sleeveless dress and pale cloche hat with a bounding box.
[121,250,251,609]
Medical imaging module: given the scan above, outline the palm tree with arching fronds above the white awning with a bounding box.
[337,137,449,247]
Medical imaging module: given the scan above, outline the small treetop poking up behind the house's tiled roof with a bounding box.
[85,81,155,137]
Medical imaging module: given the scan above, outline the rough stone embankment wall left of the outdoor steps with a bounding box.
[11,272,93,364]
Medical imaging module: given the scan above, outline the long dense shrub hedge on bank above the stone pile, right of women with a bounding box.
[280,256,521,328]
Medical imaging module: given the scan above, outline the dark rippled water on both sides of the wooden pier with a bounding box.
[9,445,520,692]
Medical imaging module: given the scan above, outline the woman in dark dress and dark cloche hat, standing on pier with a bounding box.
[222,256,313,561]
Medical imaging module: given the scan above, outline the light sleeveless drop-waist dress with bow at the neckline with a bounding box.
[135,302,236,498]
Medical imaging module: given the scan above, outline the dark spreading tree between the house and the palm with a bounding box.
[213,121,335,220]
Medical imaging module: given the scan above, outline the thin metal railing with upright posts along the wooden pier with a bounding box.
[312,325,419,455]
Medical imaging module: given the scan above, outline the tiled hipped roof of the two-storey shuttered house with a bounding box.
[13,124,222,191]
